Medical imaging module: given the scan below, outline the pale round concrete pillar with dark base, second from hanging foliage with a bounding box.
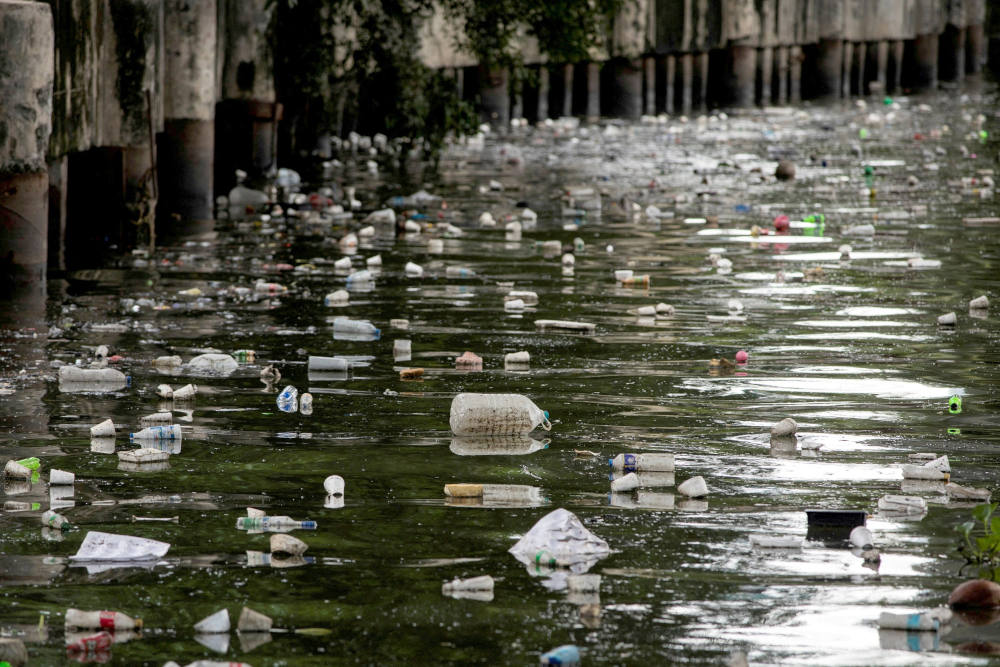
[158,0,218,235]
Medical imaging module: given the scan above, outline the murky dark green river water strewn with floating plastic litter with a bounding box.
[0,87,1000,665]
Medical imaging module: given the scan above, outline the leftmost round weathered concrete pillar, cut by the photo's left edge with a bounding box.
[0,0,55,296]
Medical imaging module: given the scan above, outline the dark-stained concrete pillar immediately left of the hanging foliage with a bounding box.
[215,0,282,194]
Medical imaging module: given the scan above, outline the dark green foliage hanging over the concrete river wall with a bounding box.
[271,0,622,164]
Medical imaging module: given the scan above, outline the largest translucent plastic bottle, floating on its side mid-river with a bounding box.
[449,394,552,435]
